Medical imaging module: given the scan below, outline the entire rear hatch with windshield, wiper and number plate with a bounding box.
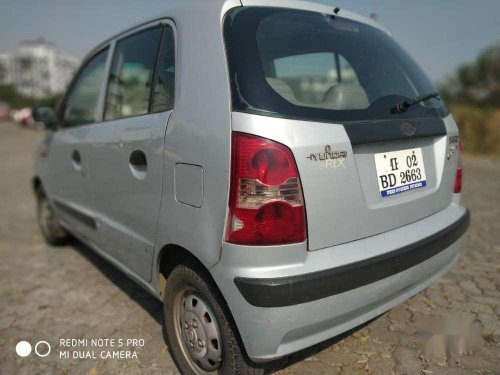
[224,1,458,250]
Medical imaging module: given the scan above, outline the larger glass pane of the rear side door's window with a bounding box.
[104,27,163,120]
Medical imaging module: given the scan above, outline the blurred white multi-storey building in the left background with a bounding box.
[12,38,78,98]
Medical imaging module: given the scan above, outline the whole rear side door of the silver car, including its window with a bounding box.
[90,21,175,280]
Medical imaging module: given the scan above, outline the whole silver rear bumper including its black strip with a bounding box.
[210,204,469,362]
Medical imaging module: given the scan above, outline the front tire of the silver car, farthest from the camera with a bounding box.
[36,188,71,246]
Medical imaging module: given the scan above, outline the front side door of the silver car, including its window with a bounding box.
[44,48,108,239]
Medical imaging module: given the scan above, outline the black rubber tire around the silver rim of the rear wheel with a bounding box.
[163,264,264,375]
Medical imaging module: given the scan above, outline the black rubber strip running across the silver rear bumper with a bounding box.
[234,210,470,307]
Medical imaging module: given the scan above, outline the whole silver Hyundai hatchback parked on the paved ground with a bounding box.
[33,0,469,373]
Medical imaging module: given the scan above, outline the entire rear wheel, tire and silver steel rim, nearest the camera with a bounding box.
[164,264,264,374]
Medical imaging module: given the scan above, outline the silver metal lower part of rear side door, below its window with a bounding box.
[88,111,171,281]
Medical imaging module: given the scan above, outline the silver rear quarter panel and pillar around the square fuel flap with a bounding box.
[151,1,240,269]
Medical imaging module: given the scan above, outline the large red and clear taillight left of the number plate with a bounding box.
[226,133,306,245]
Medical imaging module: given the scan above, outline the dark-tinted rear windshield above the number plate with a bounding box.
[224,7,447,122]
